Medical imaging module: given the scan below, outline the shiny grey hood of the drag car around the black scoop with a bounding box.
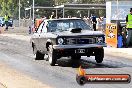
[53,30,104,36]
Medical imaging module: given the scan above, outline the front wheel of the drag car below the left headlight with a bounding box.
[48,45,57,66]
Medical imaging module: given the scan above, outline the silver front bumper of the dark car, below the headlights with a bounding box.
[53,43,107,49]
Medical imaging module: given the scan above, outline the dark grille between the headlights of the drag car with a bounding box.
[66,38,96,44]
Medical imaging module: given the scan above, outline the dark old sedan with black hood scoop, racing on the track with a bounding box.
[31,18,106,66]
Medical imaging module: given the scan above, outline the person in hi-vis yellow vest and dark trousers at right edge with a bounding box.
[126,8,132,47]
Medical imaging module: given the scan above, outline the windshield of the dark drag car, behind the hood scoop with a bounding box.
[48,19,91,32]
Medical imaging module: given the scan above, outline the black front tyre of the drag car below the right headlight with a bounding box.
[95,48,104,63]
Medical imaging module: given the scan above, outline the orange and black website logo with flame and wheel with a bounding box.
[76,67,131,85]
